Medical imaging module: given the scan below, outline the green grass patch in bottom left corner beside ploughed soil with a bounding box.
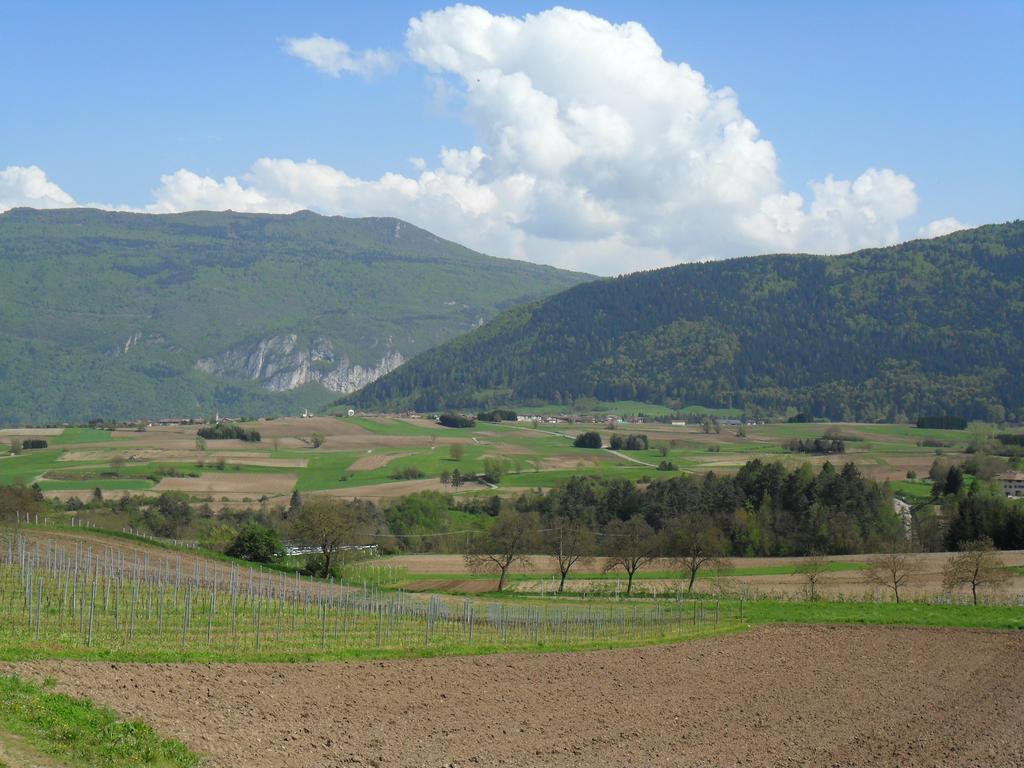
[0,677,200,768]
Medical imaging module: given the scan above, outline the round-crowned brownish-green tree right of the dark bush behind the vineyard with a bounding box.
[289,496,376,575]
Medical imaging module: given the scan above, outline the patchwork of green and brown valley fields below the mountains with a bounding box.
[0,415,1011,507]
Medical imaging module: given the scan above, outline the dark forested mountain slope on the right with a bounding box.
[355,221,1024,420]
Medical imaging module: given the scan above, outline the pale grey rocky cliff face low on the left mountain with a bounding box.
[196,334,406,393]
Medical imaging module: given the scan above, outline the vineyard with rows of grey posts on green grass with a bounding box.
[0,529,736,660]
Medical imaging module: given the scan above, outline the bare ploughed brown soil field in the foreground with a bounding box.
[0,627,1024,768]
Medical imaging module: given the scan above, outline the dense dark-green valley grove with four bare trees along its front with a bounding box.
[467,461,904,592]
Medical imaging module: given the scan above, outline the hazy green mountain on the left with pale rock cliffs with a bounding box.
[0,209,590,424]
